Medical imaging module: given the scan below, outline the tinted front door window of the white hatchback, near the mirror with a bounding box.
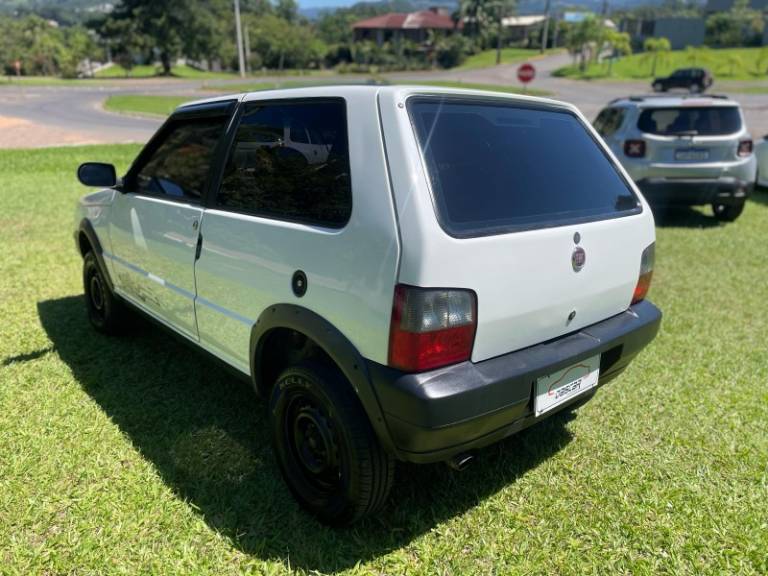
[134,116,227,201]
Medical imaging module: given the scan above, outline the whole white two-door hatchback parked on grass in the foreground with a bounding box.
[75,86,661,524]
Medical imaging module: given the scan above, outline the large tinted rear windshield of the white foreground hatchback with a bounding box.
[408,97,640,236]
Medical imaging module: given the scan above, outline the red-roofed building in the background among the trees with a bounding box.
[352,8,462,46]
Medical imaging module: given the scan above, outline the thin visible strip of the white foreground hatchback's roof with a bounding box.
[176,84,578,113]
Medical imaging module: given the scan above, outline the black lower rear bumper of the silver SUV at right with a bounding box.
[637,177,755,206]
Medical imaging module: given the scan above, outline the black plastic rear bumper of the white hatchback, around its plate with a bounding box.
[369,302,661,462]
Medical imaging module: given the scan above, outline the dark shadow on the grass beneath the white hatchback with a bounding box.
[38,296,571,573]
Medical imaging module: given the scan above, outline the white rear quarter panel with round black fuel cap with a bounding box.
[195,90,400,370]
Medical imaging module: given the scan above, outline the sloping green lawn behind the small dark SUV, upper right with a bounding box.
[555,48,768,85]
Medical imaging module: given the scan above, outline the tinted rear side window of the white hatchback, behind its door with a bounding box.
[216,99,352,228]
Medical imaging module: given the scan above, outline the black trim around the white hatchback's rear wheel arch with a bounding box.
[250,304,398,456]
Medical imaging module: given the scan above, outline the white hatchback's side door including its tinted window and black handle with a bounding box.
[110,102,233,339]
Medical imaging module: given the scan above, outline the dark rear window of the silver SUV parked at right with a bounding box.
[637,106,741,136]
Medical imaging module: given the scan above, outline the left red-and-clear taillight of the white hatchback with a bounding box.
[389,284,477,372]
